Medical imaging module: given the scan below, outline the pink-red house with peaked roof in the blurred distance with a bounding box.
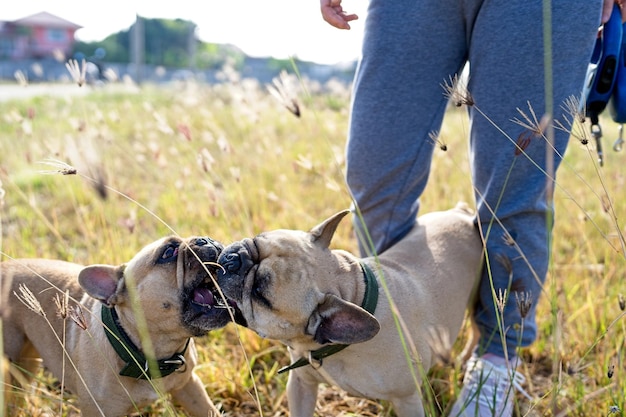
[0,12,82,60]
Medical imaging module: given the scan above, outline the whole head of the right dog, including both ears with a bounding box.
[218,210,380,347]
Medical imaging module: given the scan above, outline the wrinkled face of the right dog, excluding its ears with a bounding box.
[218,230,324,341]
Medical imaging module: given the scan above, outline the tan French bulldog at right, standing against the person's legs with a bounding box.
[218,204,483,417]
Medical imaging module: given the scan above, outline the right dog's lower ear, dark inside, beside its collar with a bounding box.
[307,294,380,345]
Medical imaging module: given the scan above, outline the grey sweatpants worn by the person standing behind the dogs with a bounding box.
[346,0,602,356]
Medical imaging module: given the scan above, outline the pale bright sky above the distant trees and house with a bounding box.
[0,0,367,64]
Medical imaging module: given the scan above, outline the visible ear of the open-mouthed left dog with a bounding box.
[78,265,124,306]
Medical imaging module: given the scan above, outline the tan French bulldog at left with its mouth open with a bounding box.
[0,236,231,417]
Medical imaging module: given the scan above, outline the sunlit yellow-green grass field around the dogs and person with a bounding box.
[0,66,626,417]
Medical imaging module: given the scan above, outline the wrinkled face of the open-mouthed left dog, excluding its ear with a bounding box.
[113,236,231,336]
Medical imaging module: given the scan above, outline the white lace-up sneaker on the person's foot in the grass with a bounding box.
[449,356,531,417]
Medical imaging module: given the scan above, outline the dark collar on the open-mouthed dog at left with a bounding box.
[100,305,191,379]
